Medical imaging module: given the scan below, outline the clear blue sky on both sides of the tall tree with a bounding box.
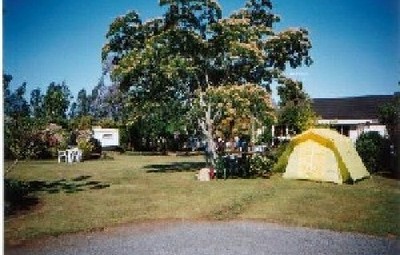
[3,0,400,100]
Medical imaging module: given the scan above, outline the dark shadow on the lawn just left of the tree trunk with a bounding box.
[145,162,206,173]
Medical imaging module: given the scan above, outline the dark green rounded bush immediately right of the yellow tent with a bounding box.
[356,132,390,173]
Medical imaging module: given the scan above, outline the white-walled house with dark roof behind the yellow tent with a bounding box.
[312,93,399,142]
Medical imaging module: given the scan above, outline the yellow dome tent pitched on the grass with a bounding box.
[283,129,369,184]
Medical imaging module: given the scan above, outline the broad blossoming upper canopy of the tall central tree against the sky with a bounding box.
[102,0,312,157]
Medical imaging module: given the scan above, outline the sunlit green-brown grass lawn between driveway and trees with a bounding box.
[4,155,400,244]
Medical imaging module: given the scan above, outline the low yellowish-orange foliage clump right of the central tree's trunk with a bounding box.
[192,84,274,139]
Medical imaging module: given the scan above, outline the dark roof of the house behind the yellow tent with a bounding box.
[312,95,395,120]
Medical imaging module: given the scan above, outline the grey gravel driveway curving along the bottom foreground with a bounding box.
[5,221,400,255]
